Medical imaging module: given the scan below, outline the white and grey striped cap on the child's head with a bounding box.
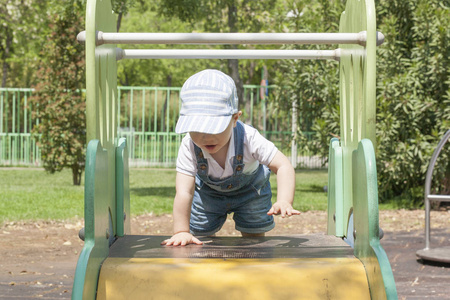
[175,70,238,134]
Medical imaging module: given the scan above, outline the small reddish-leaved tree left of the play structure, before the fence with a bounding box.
[31,2,86,185]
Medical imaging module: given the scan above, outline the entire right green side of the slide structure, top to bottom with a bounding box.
[328,0,397,299]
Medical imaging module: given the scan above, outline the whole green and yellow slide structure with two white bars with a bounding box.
[72,0,397,299]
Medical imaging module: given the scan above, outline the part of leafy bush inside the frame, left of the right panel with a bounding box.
[276,1,343,157]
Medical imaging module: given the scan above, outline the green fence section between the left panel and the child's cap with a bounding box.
[117,86,181,166]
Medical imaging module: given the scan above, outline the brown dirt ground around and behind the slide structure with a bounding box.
[0,210,450,299]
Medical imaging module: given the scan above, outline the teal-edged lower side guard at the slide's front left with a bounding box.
[72,140,111,300]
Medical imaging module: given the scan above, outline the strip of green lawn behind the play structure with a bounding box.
[0,168,328,224]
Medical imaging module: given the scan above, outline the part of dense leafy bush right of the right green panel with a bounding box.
[377,0,450,204]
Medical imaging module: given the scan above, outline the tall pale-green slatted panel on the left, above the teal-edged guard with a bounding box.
[85,0,117,244]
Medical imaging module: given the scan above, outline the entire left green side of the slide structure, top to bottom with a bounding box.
[72,0,126,299]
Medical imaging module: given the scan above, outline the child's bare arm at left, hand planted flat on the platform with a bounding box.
[161,173,203,246]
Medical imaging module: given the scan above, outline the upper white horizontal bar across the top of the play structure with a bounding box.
[77,31,384,46]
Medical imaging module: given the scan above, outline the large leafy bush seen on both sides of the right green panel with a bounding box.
[279,0,450,207]
